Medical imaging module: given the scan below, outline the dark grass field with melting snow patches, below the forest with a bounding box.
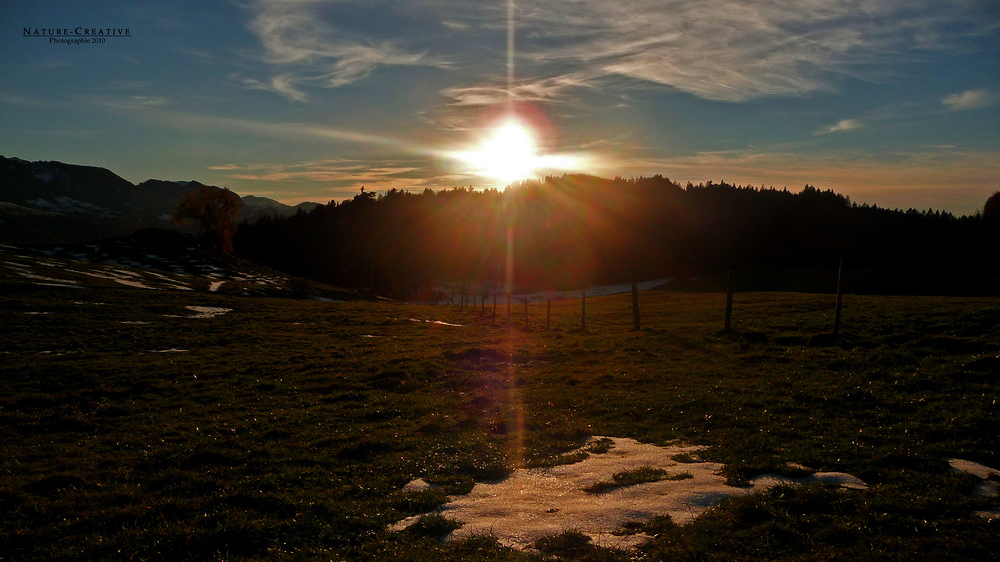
[0,266,1000,560]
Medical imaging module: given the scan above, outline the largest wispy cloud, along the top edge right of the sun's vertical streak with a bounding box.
[508,0,989,102]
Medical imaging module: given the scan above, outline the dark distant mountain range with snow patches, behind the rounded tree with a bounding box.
[0,156,318,243]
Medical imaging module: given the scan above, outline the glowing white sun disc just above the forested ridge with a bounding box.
[462,123,539,182]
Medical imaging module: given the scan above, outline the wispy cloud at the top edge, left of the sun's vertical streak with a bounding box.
[243,0,449,102]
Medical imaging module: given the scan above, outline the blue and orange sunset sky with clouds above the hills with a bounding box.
[0,0,1000,215]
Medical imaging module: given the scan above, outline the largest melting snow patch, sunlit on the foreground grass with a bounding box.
[390,437,867,549]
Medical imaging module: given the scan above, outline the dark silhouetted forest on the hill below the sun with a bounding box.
[234,175,1000,297]
